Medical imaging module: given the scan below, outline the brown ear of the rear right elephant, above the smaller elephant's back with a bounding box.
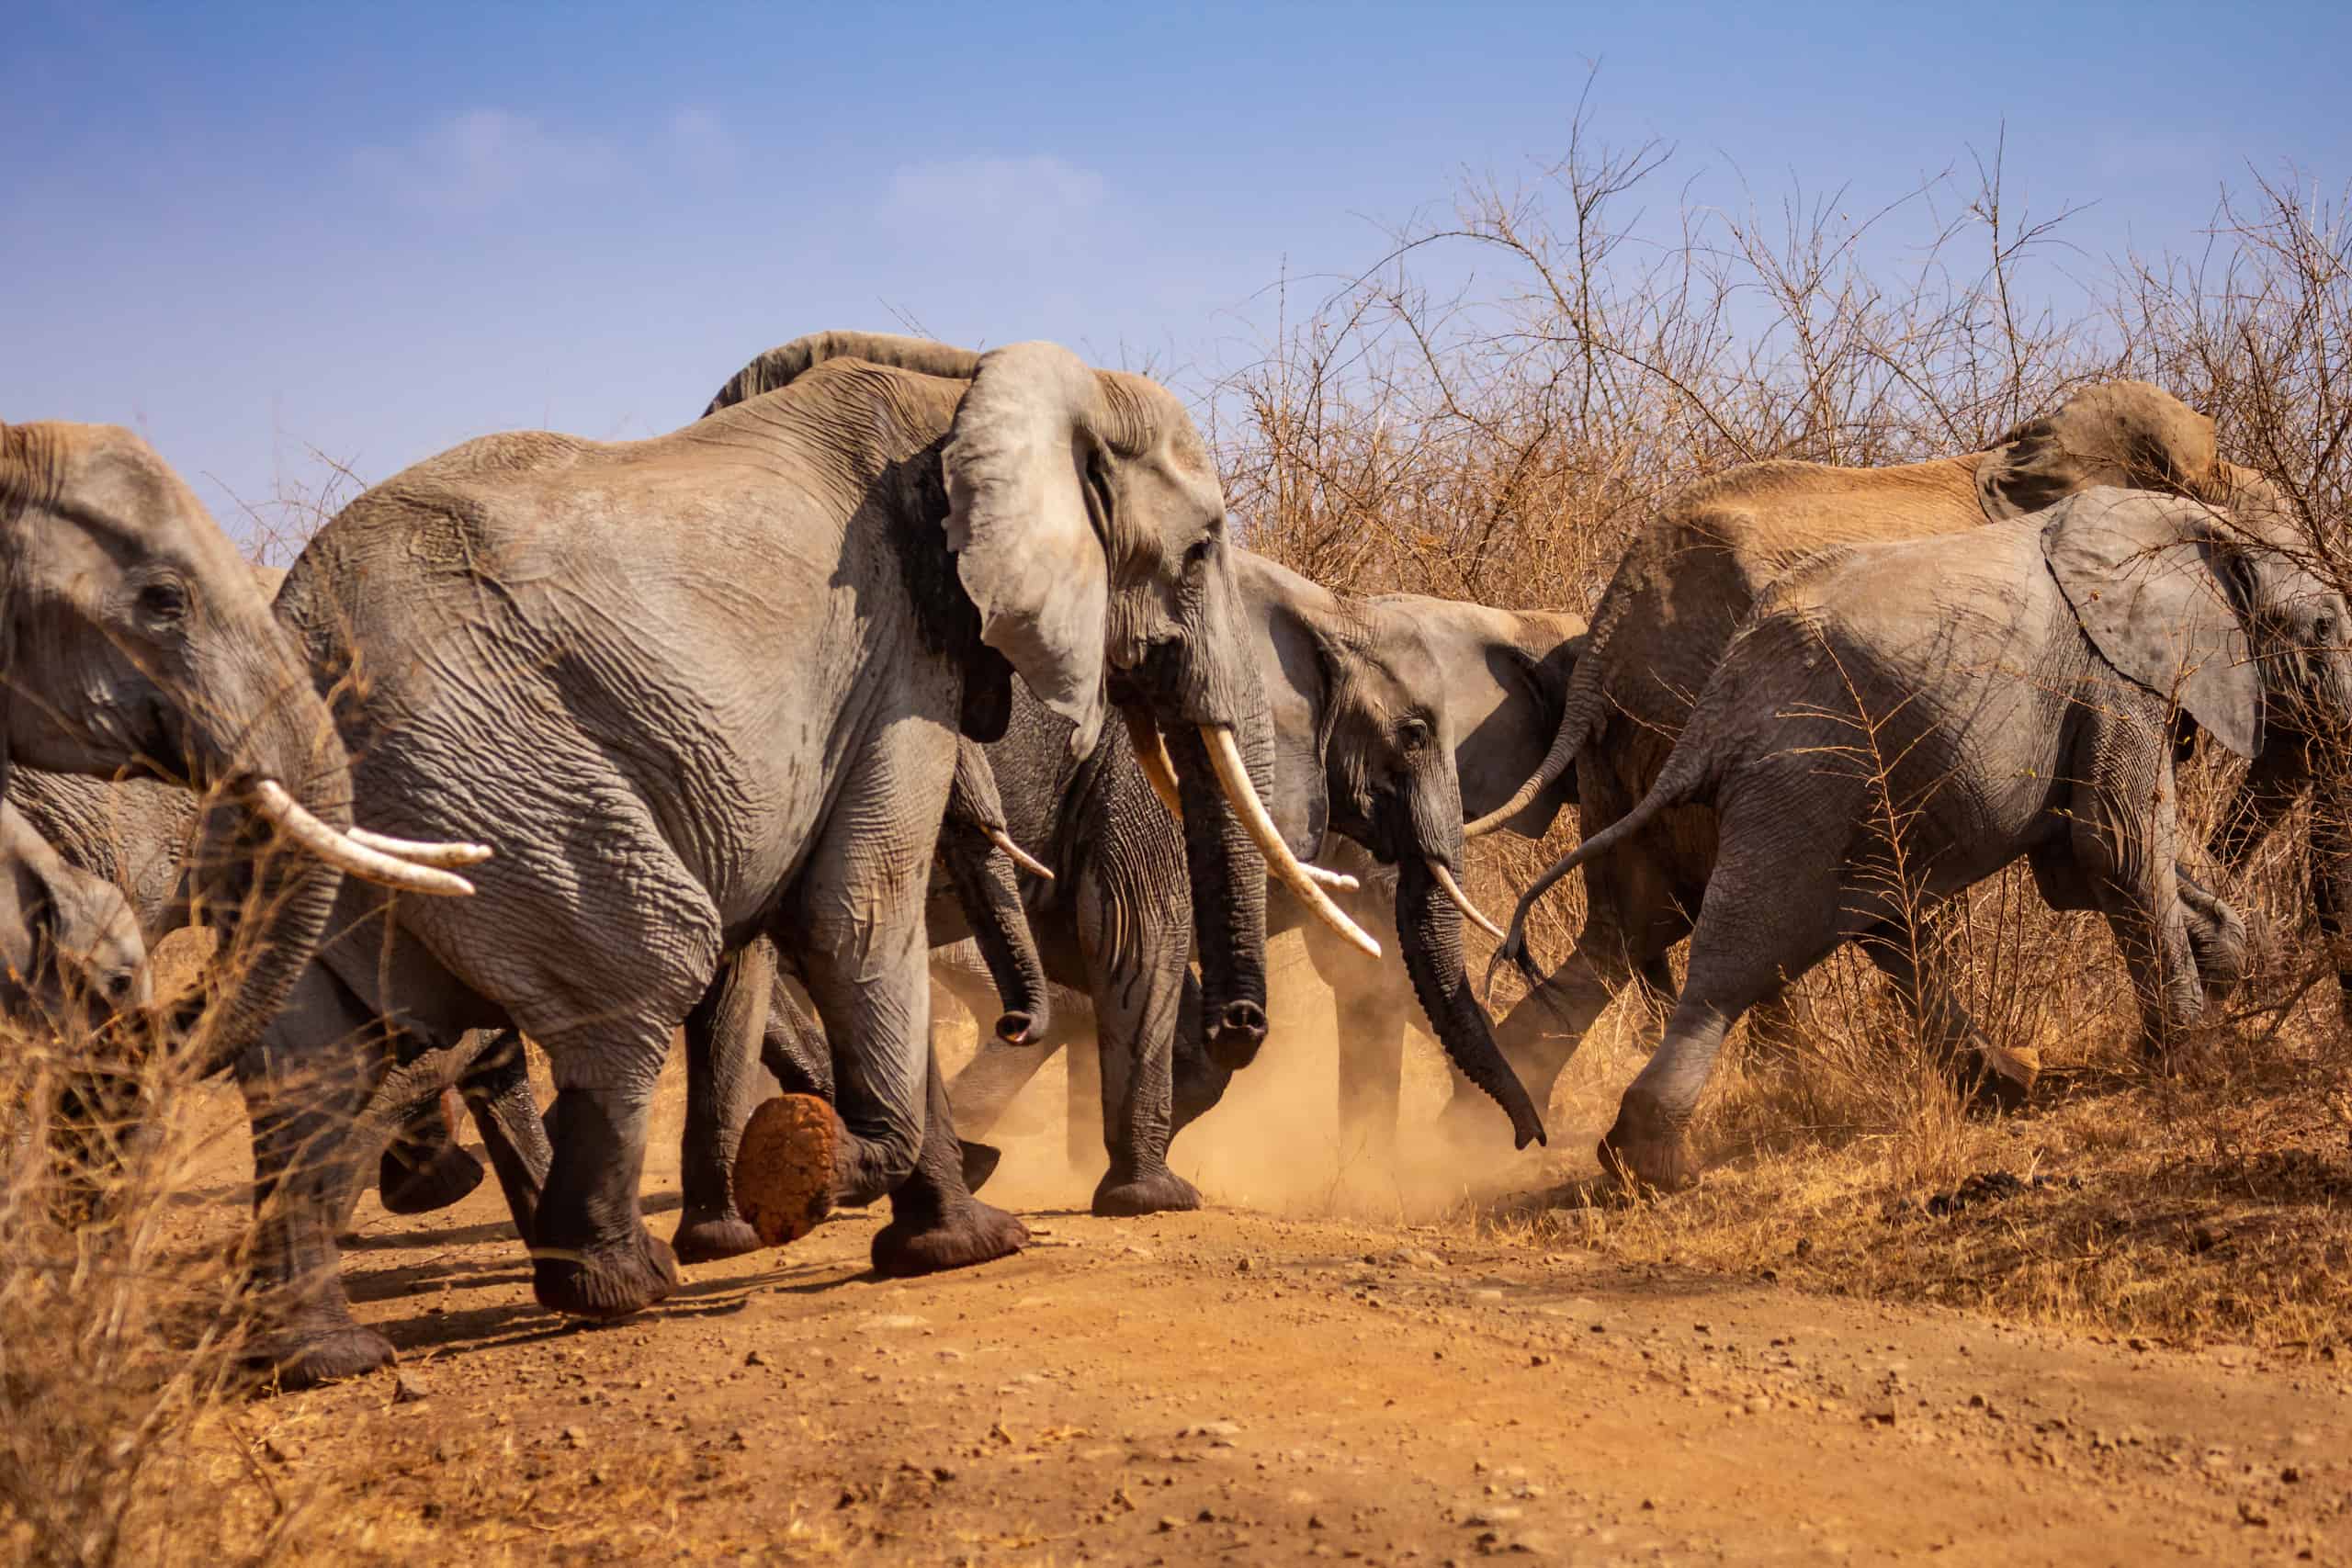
[1975,381,2221,522]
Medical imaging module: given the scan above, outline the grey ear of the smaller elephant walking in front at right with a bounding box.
[2041,489,2263,757]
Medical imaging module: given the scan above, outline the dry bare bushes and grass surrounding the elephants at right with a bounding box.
[1209,88,2352,1349]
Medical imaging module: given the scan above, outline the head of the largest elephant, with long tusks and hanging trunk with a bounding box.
[710,332,1376,1051]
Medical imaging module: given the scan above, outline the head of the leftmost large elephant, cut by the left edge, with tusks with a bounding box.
[0,423,489,1058]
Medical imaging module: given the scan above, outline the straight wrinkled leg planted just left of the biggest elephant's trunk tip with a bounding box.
[1070,844,1206,1215]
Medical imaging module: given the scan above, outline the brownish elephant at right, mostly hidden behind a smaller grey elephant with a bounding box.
[1467,381,2314,1102]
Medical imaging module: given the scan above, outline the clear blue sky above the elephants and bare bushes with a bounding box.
[0,0,2352,536]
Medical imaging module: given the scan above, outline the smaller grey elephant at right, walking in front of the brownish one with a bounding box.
[1512,489,2352,1190]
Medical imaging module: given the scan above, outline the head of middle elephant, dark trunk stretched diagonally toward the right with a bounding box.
[1235,550,1545,1149]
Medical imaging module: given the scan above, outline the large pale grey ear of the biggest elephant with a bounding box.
[941,344,1110,757]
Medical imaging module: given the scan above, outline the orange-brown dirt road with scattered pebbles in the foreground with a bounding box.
[247,1142,2352,1565]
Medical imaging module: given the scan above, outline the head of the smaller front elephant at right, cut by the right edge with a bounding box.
[2041,491,2352,995]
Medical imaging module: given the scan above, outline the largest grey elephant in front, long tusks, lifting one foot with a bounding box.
[238,333,1369,1384]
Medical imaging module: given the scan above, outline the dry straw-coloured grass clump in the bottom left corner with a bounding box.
[0,940,308,1568]
